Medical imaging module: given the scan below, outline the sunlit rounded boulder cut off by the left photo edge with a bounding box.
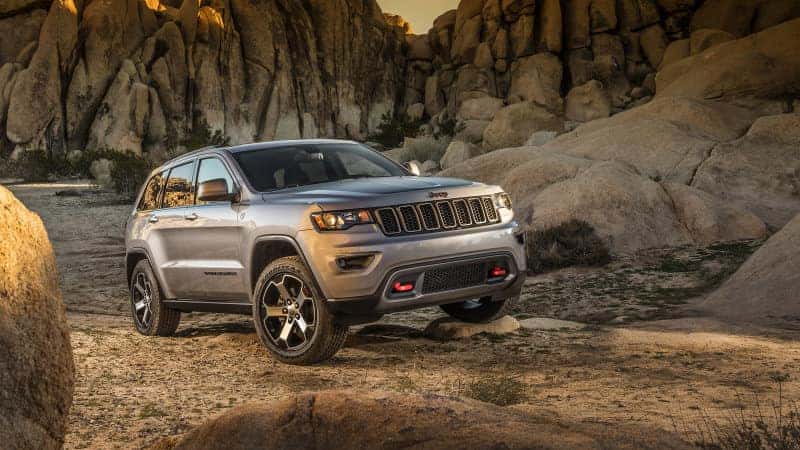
[0,186,75,449]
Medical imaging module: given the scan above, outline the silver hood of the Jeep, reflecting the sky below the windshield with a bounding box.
[263,176,486,209]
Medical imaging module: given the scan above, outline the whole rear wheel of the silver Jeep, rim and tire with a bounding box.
[130,259,181,336]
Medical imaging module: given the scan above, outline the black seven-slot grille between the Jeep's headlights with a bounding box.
[375,197,500,236]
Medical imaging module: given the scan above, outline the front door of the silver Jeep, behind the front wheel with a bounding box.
[182,156,249,301]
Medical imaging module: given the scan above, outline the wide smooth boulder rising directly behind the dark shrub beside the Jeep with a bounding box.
[518,162,766,253]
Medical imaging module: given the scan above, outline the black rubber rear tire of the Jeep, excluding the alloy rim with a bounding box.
[129,259,181,337]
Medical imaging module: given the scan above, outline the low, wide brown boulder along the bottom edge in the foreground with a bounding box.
[157,391,686,450]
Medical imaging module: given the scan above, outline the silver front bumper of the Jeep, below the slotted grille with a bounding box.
[298,218,526,315]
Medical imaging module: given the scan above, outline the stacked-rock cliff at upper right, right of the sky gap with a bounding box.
[404,0,800,150]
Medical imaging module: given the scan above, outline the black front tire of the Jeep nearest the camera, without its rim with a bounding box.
[253,256,347,365]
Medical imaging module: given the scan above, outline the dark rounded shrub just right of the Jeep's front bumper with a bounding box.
[526,219,611,273]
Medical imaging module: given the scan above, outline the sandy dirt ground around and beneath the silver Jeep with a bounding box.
[10,183,800,449]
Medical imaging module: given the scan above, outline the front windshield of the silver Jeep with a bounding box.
[233,143,408,192]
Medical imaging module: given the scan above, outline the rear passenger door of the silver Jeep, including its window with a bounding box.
[149,161,195,298]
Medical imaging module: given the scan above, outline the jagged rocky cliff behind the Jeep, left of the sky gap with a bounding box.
[0,0,405,159]
